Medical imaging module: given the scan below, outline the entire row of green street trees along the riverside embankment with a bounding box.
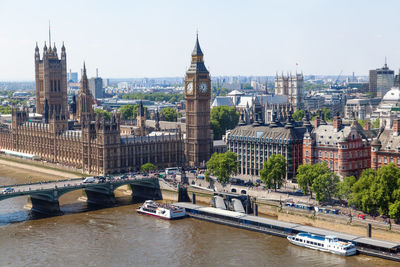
[206,151,400,220]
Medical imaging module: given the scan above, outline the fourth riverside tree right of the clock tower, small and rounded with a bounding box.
[311,172,340,203]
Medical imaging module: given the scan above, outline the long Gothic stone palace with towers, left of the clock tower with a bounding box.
[0,42,186,174]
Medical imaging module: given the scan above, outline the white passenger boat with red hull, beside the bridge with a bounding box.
[136,200,186,220]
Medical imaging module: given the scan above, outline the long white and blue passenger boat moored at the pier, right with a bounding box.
[287,233,357,256]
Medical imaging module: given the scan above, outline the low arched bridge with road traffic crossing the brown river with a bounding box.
[0,177,162,215]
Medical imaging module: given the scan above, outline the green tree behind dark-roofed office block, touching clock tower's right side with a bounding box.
[210,106,239,140]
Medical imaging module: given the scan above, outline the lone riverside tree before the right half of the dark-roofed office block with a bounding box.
[260,155,286,191]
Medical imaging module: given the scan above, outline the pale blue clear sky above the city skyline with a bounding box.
[0,0,400,81]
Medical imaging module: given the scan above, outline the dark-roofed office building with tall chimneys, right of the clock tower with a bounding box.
[225,112,311,179]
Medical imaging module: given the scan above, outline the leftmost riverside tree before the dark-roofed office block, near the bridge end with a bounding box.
[207,151,239,183]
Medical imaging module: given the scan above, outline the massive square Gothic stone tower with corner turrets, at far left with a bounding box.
[35,43,68,116]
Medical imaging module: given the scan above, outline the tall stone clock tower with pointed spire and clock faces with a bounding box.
[185,36,212,167]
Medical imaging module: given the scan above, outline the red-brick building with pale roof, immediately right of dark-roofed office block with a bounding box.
[303,116,373,177]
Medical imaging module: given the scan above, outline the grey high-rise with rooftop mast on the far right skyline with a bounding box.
[369,61,394,98]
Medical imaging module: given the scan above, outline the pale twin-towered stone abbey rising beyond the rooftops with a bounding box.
[275,73,304,110]
